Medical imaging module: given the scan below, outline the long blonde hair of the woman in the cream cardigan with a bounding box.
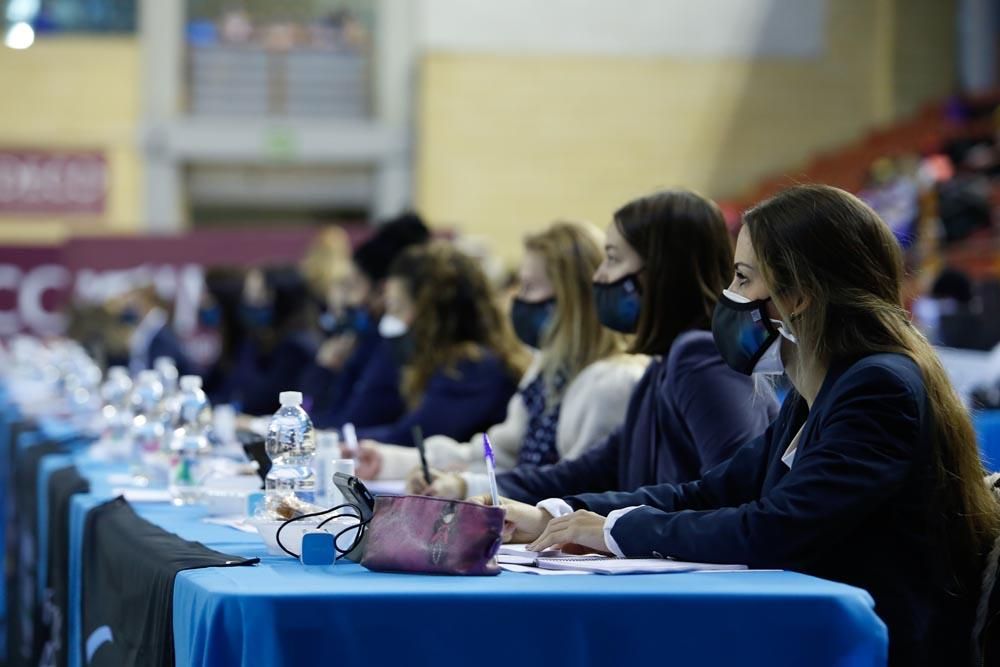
[524,221,625,405]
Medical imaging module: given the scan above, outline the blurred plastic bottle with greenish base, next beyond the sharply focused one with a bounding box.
[170,375,212,505]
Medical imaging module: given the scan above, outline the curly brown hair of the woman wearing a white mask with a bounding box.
[388,241,528,405]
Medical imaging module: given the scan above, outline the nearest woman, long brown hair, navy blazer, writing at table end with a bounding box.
[496,186,998,665]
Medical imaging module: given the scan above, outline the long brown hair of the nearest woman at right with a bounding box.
[743,185,998,571]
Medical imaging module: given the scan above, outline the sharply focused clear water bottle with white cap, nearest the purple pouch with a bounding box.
[264,391,316,518]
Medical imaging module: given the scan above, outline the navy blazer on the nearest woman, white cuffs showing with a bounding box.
[567,354,980,665]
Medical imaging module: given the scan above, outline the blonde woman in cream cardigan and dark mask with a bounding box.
[358,222,646,488]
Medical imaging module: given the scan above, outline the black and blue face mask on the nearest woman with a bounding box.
[712,290,793,375]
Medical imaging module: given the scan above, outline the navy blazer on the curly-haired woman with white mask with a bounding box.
[358,351,517,446]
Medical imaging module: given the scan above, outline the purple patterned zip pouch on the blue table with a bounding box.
[361,496,505,575]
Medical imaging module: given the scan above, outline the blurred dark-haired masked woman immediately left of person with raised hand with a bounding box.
[232,267,317,415]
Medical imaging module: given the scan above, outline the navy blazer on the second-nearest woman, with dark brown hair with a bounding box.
[497,331,778,503]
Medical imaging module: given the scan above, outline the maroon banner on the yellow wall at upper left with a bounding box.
[0,150,108,216]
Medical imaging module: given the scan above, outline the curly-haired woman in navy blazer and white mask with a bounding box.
[357,241,528,445]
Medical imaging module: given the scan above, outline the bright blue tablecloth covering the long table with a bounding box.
[3,402,887,667]
